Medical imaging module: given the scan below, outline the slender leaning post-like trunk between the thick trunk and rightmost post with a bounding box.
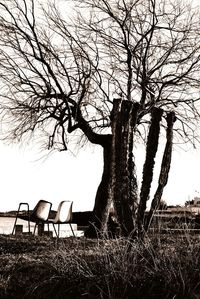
[137,108,163,236]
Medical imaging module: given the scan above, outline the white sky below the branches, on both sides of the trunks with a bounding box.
[0,139,200,211]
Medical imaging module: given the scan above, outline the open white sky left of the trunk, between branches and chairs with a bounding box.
[0,143,102,211]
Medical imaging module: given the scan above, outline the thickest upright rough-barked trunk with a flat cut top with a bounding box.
[110,99,139,236]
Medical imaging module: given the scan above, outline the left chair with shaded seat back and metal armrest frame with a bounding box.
[12,199,52,234]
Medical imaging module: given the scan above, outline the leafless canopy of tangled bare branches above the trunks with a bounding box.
[0,0,200,149]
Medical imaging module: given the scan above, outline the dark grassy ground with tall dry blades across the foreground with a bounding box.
[0,232,200,299]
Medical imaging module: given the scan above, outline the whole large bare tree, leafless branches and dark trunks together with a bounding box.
[0,0,200,239]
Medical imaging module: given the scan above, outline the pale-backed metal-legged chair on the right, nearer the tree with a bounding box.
[45,201,75,238]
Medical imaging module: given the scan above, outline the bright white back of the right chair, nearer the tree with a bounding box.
[55,200,73,223]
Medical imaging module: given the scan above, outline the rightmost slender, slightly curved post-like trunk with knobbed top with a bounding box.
[145,112,176,231]
